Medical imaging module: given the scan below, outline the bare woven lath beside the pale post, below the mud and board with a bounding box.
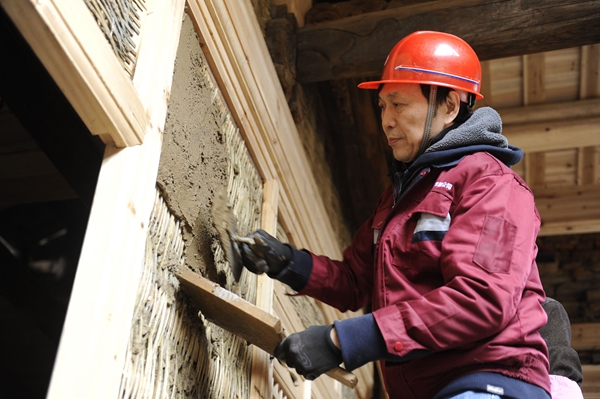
[120,191,258,399]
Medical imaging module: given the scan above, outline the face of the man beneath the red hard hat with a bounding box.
[379,83,443,162]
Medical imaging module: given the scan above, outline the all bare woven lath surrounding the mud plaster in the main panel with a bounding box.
[121,50,262,399]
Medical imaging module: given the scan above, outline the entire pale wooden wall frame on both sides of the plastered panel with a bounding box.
[0,0,372,399]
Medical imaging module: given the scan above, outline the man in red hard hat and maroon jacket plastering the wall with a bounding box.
[240,31,550,399]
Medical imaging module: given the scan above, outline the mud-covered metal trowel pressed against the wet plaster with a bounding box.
[211,188,255,281]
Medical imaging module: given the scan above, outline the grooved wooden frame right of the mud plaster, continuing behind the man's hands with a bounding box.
[188,0,373,398]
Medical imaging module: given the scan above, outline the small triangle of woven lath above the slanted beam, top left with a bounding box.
[83,0,146,76]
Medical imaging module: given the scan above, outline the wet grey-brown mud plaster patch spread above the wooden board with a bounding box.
[157,16,227,280]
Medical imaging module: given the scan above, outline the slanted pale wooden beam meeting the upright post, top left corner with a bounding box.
[0,0,148,147]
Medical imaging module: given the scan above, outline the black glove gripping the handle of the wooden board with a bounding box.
[274,325,343,380]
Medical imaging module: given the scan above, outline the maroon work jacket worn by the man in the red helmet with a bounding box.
[300,152,550,398]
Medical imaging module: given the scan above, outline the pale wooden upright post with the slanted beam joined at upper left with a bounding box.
[16,0,185,399]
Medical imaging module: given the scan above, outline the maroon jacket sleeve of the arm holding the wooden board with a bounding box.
[374,166,546,356]
